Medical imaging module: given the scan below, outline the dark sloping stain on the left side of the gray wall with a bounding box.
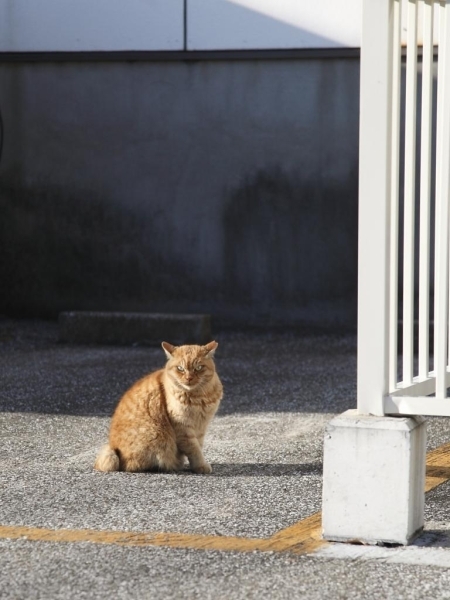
[0,186,196,317]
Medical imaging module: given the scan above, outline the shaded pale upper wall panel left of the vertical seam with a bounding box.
[0,0,184,52]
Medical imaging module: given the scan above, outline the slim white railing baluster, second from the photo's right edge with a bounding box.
[419,0,434,378]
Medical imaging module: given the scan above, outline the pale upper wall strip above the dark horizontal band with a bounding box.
[0,0,439,52]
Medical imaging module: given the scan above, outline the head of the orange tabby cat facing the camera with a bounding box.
[161,342,219,391]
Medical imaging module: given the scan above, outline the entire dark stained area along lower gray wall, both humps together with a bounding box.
[0,169,357,327]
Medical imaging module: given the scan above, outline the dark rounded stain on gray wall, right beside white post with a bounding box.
[225,168,358,322]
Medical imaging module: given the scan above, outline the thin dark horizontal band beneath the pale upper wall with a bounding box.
[0,48,360,63]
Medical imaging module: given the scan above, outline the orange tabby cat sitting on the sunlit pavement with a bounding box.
[94,342,222,473]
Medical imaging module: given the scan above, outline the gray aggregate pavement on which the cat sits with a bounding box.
[0,319,450,600]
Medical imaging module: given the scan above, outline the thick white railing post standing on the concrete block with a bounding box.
[358,0,394,415]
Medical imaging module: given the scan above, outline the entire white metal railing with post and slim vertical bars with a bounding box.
[358,0,450,416]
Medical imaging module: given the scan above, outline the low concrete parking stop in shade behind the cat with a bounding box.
[58,311,212,345]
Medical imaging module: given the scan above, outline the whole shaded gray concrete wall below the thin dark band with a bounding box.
[0,58,359,325]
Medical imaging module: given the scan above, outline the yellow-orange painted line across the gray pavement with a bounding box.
[0,443,450,554]
